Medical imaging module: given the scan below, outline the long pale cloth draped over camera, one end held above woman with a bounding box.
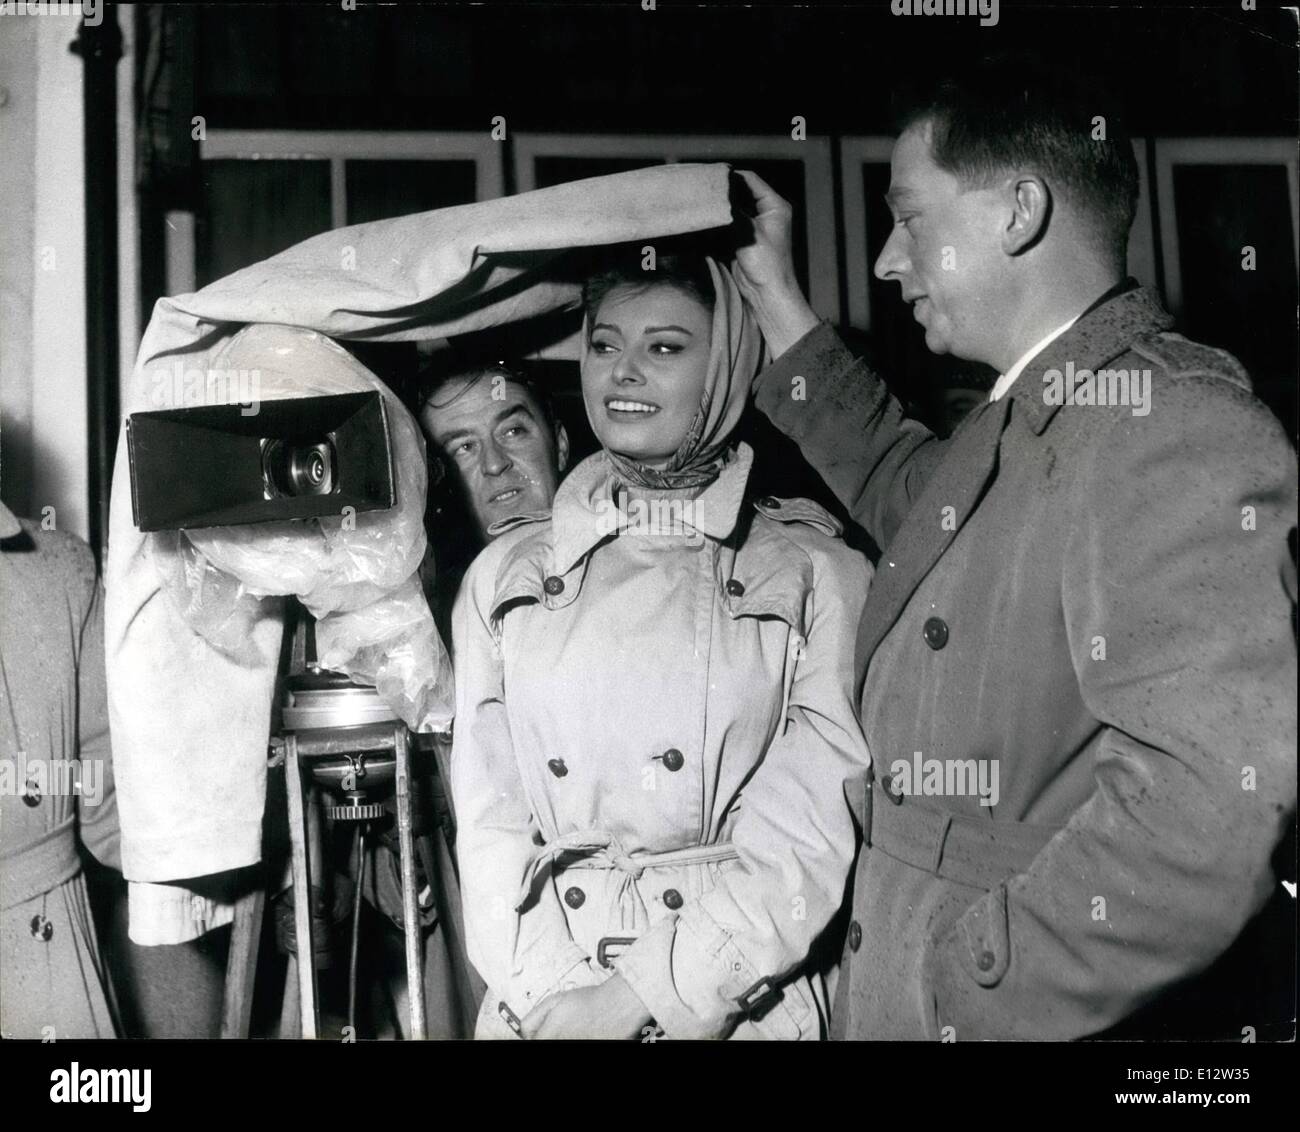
[107,165,731,881]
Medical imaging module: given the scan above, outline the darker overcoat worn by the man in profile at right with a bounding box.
[757,290,1297,1040]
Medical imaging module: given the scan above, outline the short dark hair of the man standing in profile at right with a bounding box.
[898,55,1138,260]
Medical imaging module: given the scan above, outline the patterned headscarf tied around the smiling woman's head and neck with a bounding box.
[580,256,763,489]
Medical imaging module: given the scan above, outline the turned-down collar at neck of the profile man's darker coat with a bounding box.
[1006,287,1174,435]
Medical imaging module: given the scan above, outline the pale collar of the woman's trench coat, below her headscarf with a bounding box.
[551,443,754,574]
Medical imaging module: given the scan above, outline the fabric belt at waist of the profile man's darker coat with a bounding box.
[870,784,1060,889]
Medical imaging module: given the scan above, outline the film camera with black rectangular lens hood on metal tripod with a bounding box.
[126,391,434,1038]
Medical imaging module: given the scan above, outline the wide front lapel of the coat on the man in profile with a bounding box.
[854,396,1010,695]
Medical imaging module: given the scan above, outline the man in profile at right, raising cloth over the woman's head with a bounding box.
[737,57,1296,1041]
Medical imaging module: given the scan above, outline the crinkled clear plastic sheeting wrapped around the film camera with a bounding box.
[155,324,454,730]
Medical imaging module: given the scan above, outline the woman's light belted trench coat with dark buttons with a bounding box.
[451,444,871,1038]
